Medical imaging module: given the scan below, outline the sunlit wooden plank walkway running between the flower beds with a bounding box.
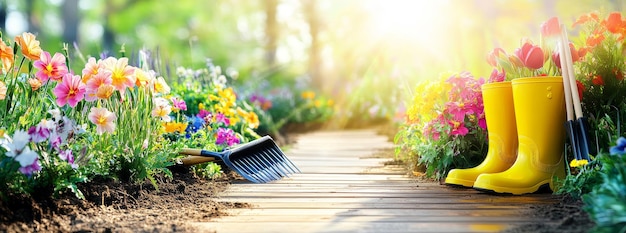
[193,130,557,233]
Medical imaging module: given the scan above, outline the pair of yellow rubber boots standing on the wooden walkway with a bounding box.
[445,77,565,194]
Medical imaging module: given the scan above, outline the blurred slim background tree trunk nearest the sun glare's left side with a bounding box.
[303,0,324,90]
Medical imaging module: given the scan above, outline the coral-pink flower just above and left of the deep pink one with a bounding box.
[33,51,68,83]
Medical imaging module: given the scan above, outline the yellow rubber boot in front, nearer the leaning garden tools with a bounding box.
[474,77,565,194]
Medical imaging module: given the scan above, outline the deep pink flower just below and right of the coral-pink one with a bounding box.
[53,73,85,108]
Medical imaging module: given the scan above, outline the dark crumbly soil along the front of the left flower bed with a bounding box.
[0,170,249,232]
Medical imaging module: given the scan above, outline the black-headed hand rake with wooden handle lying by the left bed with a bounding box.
[173,136,300,183]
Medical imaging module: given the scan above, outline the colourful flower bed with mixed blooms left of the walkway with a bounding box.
[0,33,332,206]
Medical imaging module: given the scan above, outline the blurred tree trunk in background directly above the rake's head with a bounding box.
[265,0,278,67]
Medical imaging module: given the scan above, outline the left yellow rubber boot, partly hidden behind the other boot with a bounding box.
[445,82,517,187]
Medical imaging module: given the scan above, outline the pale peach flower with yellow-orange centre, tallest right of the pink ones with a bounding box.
[102,57,136,93]
